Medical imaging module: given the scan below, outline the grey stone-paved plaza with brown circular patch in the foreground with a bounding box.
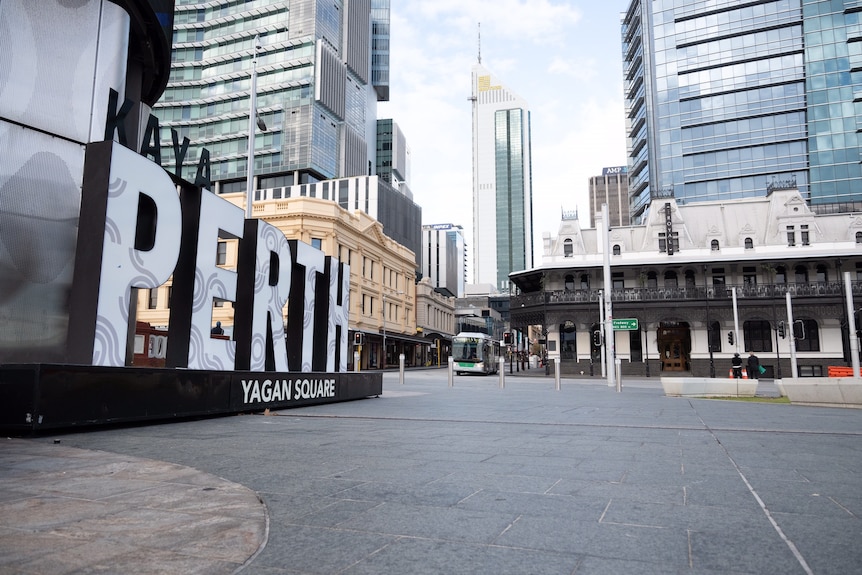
[0,370,862,575]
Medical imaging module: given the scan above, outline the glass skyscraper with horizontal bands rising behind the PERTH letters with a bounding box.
[155,0,389,192]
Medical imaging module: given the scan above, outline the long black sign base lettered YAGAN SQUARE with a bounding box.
[0,364,383,433]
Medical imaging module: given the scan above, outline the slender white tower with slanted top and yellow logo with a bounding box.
[471,63,533,291]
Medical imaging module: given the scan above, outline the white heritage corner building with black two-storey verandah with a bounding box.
[510,187,862,377]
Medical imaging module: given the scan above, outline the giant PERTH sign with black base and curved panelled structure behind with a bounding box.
[0,0,382,430]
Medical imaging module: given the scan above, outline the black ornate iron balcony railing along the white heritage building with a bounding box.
[512,281,862,308]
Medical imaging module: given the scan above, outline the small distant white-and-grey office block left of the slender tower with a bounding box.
[421,224,467,297]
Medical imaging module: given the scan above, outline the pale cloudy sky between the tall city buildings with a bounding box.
[377,0,629,282]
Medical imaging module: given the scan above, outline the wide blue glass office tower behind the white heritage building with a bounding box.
[622,0,862,221]
